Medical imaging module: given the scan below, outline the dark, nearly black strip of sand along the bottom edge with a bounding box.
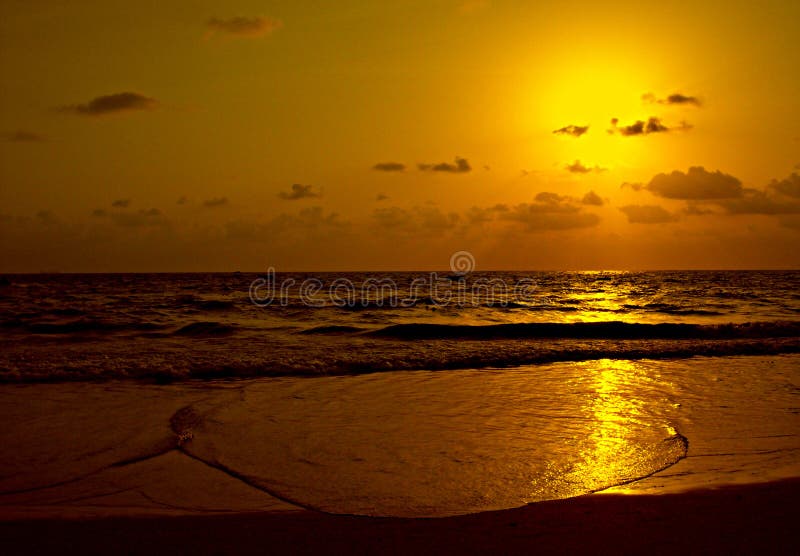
[0,479,800,555]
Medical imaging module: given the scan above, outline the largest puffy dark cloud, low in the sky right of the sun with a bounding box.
[646,166,742,201]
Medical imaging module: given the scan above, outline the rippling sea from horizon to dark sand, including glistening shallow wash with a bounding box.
[0,271,800,516]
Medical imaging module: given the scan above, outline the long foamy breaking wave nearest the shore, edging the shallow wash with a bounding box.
[0,334,800,382]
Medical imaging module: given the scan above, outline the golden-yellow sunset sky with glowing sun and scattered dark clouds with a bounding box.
[0,0,800,272]
